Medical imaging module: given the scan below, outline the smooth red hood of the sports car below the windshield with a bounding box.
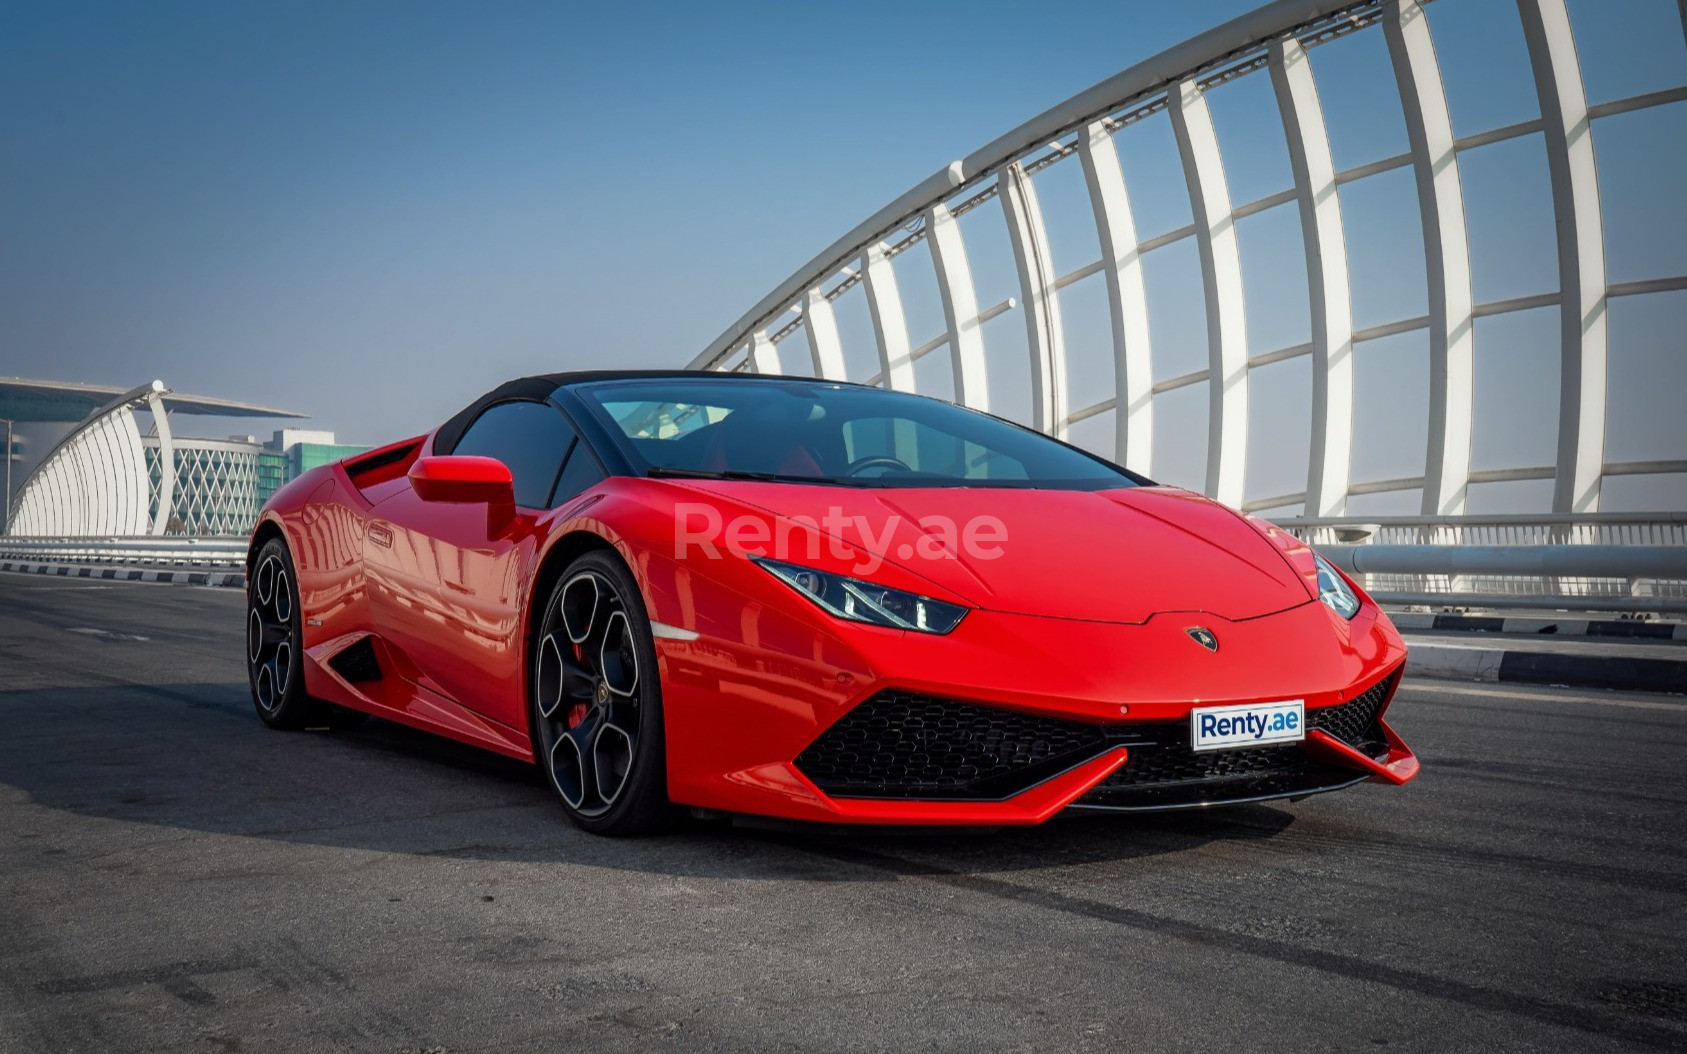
[657,479,1314,622]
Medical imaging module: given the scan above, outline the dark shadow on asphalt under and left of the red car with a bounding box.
[0,683,1296,882]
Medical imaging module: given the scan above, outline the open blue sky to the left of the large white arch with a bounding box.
[0,0,1268,430]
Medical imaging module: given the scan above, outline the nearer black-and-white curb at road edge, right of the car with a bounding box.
[1405,643,1687,695]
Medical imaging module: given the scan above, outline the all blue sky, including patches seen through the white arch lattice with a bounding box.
[0,0,1687,504]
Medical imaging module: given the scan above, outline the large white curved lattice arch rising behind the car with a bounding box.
[692,0,1687,518]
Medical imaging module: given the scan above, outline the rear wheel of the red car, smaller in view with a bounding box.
[246,538,327,729]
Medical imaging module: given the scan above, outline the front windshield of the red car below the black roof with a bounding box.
[575,378,1145,491]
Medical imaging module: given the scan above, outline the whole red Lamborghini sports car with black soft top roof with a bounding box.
[246,373,1419,833]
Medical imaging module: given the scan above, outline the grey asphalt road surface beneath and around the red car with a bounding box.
[0,575,1687,1054]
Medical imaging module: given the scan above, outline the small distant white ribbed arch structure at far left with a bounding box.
[7,381,175,538]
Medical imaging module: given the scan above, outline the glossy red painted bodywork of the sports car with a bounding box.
[255,403,1417,825]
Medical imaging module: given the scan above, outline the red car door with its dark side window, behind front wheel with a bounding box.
[364,400,577,729]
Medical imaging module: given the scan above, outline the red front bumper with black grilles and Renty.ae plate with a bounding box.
[661,602,1417,825]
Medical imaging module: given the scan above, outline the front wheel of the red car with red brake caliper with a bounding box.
[528,550,673,835]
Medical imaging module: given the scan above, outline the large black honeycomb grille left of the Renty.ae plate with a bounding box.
[796,691,1107,799]
